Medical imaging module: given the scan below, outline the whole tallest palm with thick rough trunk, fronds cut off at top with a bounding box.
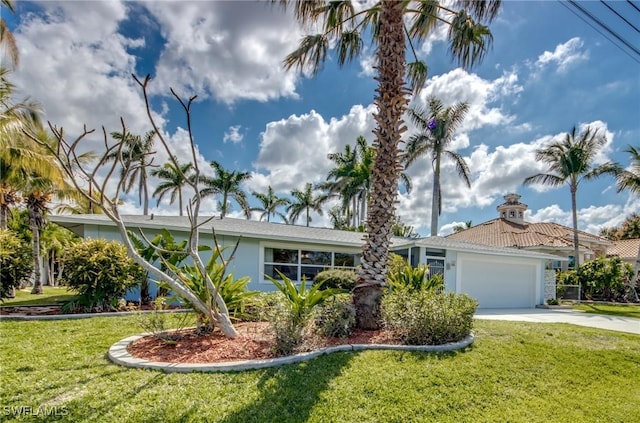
[280,0,500,329]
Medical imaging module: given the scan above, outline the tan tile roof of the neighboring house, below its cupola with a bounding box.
[447,218,611,249]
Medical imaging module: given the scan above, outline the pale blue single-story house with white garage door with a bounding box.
[50,214,563,308]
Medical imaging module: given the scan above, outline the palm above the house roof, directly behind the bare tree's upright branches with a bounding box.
[107,129,156,216]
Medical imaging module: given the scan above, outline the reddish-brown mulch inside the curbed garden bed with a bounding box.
[128,322,400,363]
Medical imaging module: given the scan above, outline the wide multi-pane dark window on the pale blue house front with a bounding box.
[263,247,360,282]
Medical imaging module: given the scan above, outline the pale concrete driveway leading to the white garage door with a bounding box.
[475,308,640,335]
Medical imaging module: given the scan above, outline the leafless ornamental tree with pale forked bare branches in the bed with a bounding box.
[26,75,238,338]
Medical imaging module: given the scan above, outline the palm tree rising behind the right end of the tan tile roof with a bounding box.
[524,126,619,269]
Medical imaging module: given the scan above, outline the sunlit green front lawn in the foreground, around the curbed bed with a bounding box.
[0,316,640,423]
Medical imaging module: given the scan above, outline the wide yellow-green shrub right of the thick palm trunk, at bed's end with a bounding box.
[382,289,478,345]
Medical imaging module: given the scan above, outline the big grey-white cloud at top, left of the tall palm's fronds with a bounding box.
[145,2,301,103]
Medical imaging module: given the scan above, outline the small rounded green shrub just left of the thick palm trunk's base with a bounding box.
[314,296,356,338]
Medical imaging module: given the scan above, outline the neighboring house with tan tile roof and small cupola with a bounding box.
[446,194,608,270]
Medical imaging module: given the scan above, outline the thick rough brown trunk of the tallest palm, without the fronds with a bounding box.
[353,1,408,330]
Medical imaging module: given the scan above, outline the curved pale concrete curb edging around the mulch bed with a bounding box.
[107,333,475,373]
